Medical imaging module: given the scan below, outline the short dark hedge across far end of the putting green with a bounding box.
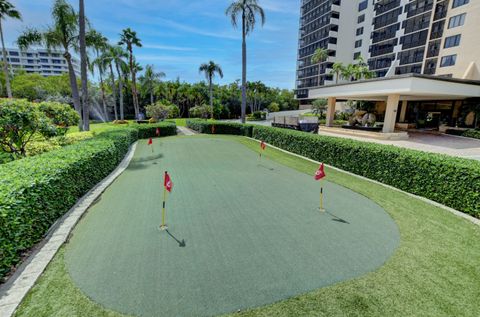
[187,119,254,137]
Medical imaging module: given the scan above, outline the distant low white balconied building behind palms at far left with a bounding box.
[0,48,80,76]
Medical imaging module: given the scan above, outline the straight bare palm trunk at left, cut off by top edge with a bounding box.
[78,0,90,131]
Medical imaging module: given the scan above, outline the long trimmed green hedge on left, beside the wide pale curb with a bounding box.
[0,123,176,280]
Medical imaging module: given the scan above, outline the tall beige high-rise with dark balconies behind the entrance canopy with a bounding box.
[296,0,480,102]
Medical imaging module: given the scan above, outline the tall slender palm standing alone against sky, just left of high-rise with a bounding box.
[225,0,265,123]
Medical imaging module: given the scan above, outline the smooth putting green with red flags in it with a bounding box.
[66,136,400,316]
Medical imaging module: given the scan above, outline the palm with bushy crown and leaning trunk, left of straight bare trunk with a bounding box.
[17,0,83,129]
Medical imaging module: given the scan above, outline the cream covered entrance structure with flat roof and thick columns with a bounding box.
[309,74,480,133]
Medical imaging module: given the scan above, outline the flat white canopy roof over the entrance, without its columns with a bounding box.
[309,74,480,101]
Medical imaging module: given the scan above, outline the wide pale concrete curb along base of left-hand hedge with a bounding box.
[0,142,138,317]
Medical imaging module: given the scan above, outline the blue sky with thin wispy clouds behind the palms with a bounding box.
[4,0,299,88]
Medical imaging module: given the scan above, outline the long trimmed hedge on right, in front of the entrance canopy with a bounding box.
[253,126,480,218]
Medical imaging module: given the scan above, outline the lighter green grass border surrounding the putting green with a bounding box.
[16,136,480,316]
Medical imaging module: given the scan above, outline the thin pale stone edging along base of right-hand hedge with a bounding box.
[247,137,480,226]
